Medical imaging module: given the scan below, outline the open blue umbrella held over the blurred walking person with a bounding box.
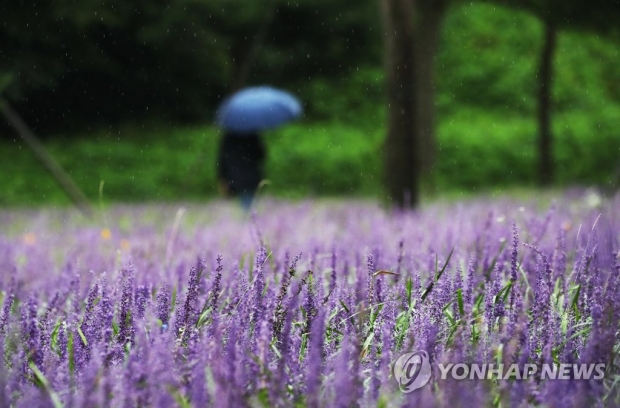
[215,86,302,134]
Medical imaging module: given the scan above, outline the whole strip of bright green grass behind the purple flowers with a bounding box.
[0,106,620,206]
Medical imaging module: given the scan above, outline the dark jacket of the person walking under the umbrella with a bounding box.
[217,133,265,195]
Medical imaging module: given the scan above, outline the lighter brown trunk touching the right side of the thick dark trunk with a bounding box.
[414,0,448,188]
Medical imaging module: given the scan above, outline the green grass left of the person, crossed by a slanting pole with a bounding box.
[0,126,218,204]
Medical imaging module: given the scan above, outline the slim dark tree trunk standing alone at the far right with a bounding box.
[538,22,556,186]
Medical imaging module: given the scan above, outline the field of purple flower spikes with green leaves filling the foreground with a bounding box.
[0,192,620,407]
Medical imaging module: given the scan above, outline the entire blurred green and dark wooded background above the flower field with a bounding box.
[0,0,620,206]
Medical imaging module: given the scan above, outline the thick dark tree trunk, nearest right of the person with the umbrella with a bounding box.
[380,0,419,208]
